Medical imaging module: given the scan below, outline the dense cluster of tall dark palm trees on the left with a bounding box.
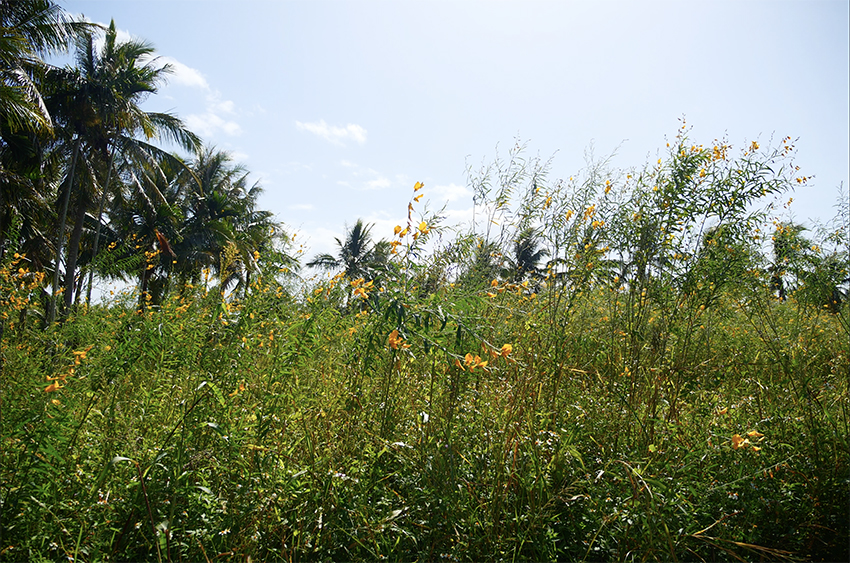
[0,0,287,326]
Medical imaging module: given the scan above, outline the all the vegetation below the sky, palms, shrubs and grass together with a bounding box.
[0,2,850,561]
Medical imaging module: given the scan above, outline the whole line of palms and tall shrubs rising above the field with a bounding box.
[0,0,848,332]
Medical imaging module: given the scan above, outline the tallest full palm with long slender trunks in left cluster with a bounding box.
[48,21,200,321]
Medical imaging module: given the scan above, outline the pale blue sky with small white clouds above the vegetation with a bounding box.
[61,0,850,258]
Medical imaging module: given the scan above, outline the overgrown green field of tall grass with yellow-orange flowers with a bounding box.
[0,131,850,561]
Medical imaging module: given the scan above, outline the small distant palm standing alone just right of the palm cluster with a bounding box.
[307,219,389,281]
